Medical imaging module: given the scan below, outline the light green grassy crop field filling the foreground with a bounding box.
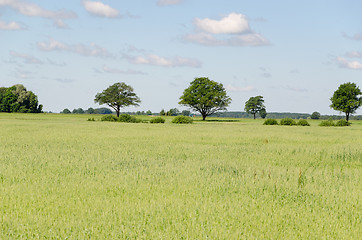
[0,113,362,239]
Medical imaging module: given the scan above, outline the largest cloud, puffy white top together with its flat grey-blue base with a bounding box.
[184,13,269,47]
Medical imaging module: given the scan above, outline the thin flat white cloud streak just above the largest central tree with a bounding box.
[124,54,202,68]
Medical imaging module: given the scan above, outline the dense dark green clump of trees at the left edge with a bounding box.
[0,84,43,113]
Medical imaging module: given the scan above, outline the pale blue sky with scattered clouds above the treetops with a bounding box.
[0,0,362,114]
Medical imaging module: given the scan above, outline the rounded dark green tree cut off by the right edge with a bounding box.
[330,82,362,122]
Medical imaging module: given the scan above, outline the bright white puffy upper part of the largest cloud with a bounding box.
[194,13,249,34]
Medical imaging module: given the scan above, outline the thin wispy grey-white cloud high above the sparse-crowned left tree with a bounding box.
[37,39,113,57]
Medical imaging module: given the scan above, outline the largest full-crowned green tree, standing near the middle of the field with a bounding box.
[179,77,231,120]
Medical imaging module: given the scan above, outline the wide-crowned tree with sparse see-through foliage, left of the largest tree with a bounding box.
[94,82,141,117]
